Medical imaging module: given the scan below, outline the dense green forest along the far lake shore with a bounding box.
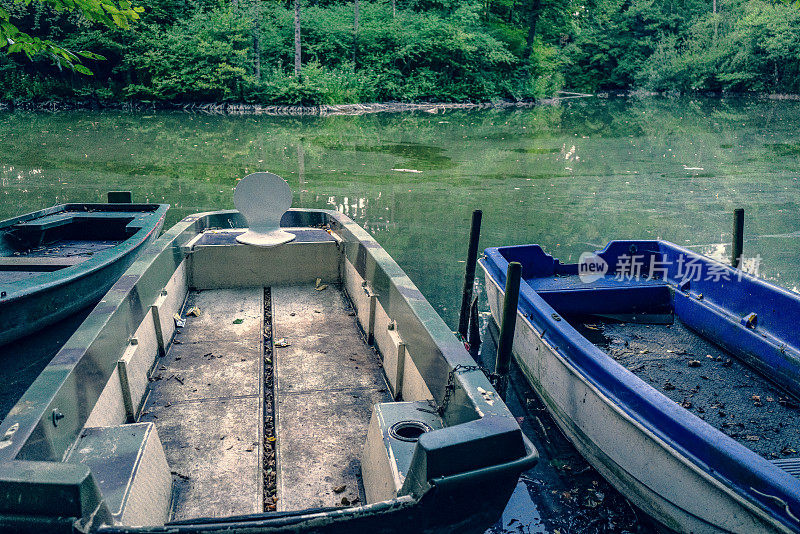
[0,0,800,105]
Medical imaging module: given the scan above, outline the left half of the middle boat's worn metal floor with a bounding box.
[141,287,264,520]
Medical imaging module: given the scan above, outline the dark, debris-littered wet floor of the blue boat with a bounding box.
[570,318,800,460]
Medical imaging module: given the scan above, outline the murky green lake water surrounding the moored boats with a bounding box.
[0,98,800,532]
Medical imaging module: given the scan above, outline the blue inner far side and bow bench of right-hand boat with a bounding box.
[497,241,800,395]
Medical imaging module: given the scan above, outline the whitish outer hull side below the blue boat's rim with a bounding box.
[481,272,791,533]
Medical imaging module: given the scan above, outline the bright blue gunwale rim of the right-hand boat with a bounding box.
[479,244,800,530]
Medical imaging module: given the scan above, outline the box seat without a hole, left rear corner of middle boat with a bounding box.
[66,423,172,525]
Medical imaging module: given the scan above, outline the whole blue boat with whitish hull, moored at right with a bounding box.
[480,241,800,532]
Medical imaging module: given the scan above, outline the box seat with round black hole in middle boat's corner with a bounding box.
[361,401,444,503]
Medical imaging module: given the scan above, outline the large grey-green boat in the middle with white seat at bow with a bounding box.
[0,173,538,533]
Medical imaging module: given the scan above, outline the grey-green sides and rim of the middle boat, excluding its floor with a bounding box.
[0,210,536,532]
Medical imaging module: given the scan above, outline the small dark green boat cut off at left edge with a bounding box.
[0,203,169,345]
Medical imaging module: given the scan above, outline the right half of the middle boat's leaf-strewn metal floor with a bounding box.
[272,284,391,510]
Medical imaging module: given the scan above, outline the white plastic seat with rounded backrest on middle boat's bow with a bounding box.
[233,172,295,247]
